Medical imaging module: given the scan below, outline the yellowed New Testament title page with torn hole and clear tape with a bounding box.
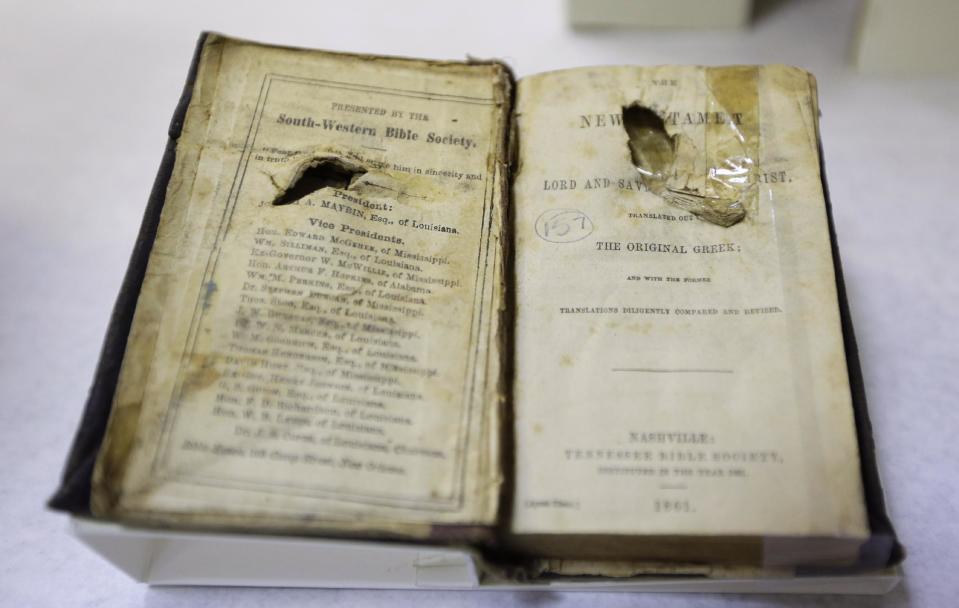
[512,66,868,565]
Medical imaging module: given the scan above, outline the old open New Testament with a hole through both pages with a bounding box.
[53,34,895,572]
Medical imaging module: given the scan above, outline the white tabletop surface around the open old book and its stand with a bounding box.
[0,0,959,607]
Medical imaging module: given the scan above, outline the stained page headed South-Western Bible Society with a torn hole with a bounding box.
[92,35,510,536]
